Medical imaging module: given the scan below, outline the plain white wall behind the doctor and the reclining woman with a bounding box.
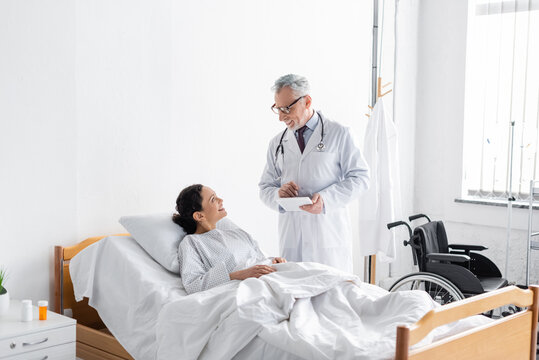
[0,0,372,306]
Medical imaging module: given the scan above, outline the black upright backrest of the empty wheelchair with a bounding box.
[412,221,449,271]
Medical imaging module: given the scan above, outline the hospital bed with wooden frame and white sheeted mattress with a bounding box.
[55,236,539,360]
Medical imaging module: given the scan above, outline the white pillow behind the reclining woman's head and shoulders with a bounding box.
[119,213,237,274]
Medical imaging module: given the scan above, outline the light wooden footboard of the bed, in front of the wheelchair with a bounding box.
[395,286,539,360]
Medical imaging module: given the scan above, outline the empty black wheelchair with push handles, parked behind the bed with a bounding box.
[387,214,507,305]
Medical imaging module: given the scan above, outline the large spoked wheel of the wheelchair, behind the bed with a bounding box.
[389,272,464,305]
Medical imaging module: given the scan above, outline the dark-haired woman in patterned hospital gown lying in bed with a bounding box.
[172,184,286,294]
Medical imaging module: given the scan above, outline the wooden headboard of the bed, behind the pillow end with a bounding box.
[54,234,129,329]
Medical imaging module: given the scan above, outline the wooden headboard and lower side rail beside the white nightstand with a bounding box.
[54,234,133,360]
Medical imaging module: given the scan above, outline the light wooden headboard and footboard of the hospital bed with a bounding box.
[54,234,539,360]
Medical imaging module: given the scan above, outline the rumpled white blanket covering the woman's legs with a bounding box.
[157,263,488,359]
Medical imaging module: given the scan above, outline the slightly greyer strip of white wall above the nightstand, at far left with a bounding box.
[0,0,77,301]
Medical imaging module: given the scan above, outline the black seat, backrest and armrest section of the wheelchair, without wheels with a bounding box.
[409,221,507,297]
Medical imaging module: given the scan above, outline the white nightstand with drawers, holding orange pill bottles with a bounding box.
[0,300,77,360]
